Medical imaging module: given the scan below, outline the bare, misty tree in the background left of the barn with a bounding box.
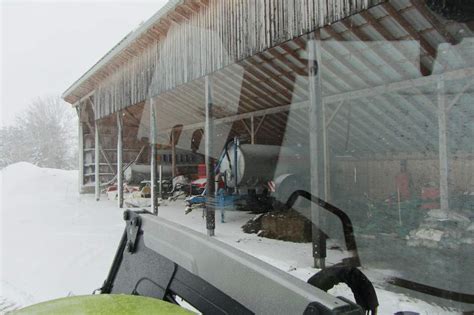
[0,97,77,169]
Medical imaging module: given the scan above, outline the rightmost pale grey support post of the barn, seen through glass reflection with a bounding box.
[437,76,449,213]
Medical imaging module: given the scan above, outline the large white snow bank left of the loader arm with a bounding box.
[0,162,123,305]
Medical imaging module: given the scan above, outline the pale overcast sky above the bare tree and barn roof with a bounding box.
[0,0,167,125]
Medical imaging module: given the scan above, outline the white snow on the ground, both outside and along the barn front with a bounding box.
[0,163,460,314]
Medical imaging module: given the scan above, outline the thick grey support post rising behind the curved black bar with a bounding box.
[307,38,326,268]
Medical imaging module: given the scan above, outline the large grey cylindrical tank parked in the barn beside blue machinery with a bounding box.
[186,138,309,212]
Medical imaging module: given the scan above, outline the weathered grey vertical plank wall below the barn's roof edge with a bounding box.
[94,0,384,119]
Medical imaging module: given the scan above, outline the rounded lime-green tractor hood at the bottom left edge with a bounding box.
[11,294,193,315]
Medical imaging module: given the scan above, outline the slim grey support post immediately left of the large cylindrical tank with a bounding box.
[204,76,216,236]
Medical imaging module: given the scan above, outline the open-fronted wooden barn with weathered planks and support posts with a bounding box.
[63,0,474,298]
